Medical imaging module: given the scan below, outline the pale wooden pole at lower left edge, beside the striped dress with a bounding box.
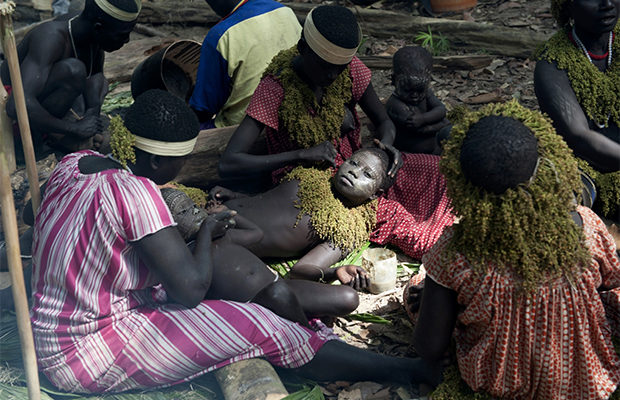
[0,140,41,400]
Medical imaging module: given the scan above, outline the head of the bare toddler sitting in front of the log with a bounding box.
[392,46,433,104]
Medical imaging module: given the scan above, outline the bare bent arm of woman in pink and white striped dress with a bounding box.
[134,212,231,308]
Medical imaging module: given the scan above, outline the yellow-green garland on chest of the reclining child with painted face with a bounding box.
[284,167,377,252]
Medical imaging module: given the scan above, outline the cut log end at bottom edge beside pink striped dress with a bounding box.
[215,358,288,400]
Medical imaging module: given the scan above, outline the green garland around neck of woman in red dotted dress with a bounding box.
[265,46,353,149]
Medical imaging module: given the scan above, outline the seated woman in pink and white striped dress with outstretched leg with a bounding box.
[31,90,436,393]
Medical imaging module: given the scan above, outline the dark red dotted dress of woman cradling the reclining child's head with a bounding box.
[246,57,453,259]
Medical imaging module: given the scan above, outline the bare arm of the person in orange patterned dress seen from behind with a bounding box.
[413,276,458,363]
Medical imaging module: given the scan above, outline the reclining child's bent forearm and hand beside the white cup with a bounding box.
[290,242,369,290]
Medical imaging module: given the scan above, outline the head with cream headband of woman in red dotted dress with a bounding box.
[297,6,362,87]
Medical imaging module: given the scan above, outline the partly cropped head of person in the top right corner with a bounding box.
[551,0,620,35]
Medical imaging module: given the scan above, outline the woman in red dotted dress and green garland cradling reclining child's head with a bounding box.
[219,6,453,258]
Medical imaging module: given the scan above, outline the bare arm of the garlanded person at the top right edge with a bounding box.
[534,61,620,172]
